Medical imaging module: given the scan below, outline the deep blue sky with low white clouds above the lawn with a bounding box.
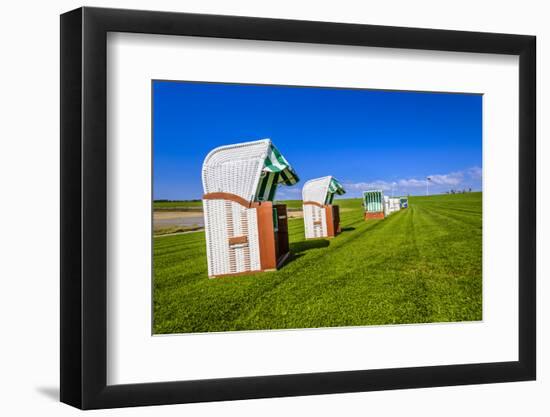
[153,81,482,200]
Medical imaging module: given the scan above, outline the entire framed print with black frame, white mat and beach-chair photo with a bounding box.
[61,8,536,409]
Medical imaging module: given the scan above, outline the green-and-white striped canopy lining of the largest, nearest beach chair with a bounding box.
[256,145,300,201]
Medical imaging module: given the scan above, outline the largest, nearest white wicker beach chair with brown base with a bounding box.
[202,139,298,277]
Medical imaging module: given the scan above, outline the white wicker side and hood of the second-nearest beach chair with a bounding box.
[302,175,332,239]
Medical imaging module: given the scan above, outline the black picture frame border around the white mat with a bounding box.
[60,7,536,409]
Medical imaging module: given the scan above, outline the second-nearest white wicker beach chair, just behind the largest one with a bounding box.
[302,176,346,239]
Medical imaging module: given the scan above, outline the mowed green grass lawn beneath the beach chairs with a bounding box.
[153,193,482,334]
